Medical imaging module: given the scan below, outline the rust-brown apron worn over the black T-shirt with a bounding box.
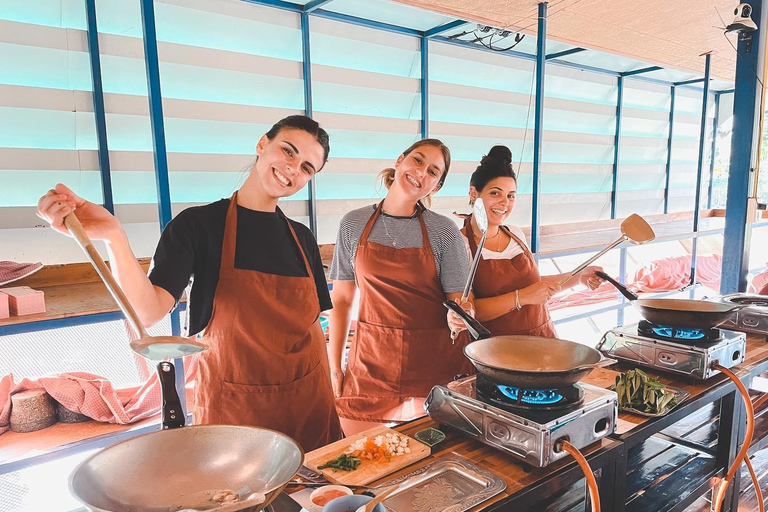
[195,192,341,451]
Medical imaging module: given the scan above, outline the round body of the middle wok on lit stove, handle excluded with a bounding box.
[464,336,616,389]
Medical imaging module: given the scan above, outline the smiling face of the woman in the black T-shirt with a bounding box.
[255,128,325,199]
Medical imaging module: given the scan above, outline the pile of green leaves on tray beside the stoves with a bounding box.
[613,369,677,414]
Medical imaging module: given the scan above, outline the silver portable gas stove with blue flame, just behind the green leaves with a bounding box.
[597,320,747,380]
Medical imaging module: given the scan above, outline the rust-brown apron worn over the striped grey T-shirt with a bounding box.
[336,204,472,422]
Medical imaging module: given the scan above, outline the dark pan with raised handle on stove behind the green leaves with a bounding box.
[595,272,747,329]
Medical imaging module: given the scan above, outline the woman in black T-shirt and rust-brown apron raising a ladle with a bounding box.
[38,116,341,451]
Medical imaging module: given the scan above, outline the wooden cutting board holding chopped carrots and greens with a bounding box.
[304,426,431,485]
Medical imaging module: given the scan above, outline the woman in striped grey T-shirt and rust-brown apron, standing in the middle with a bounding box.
[330,139,471,436]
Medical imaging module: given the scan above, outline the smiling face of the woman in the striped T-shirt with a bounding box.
[390,145,445,201]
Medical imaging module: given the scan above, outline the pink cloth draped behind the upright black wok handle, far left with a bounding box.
[0,357,197,434]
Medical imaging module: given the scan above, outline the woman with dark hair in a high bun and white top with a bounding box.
[461,146,602,338]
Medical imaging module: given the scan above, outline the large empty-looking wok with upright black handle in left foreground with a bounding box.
[69,362,304,512]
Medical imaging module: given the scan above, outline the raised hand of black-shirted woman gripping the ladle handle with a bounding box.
[37,183,121,241]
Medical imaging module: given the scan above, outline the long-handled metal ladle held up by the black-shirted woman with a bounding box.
[64,212,208,360]
